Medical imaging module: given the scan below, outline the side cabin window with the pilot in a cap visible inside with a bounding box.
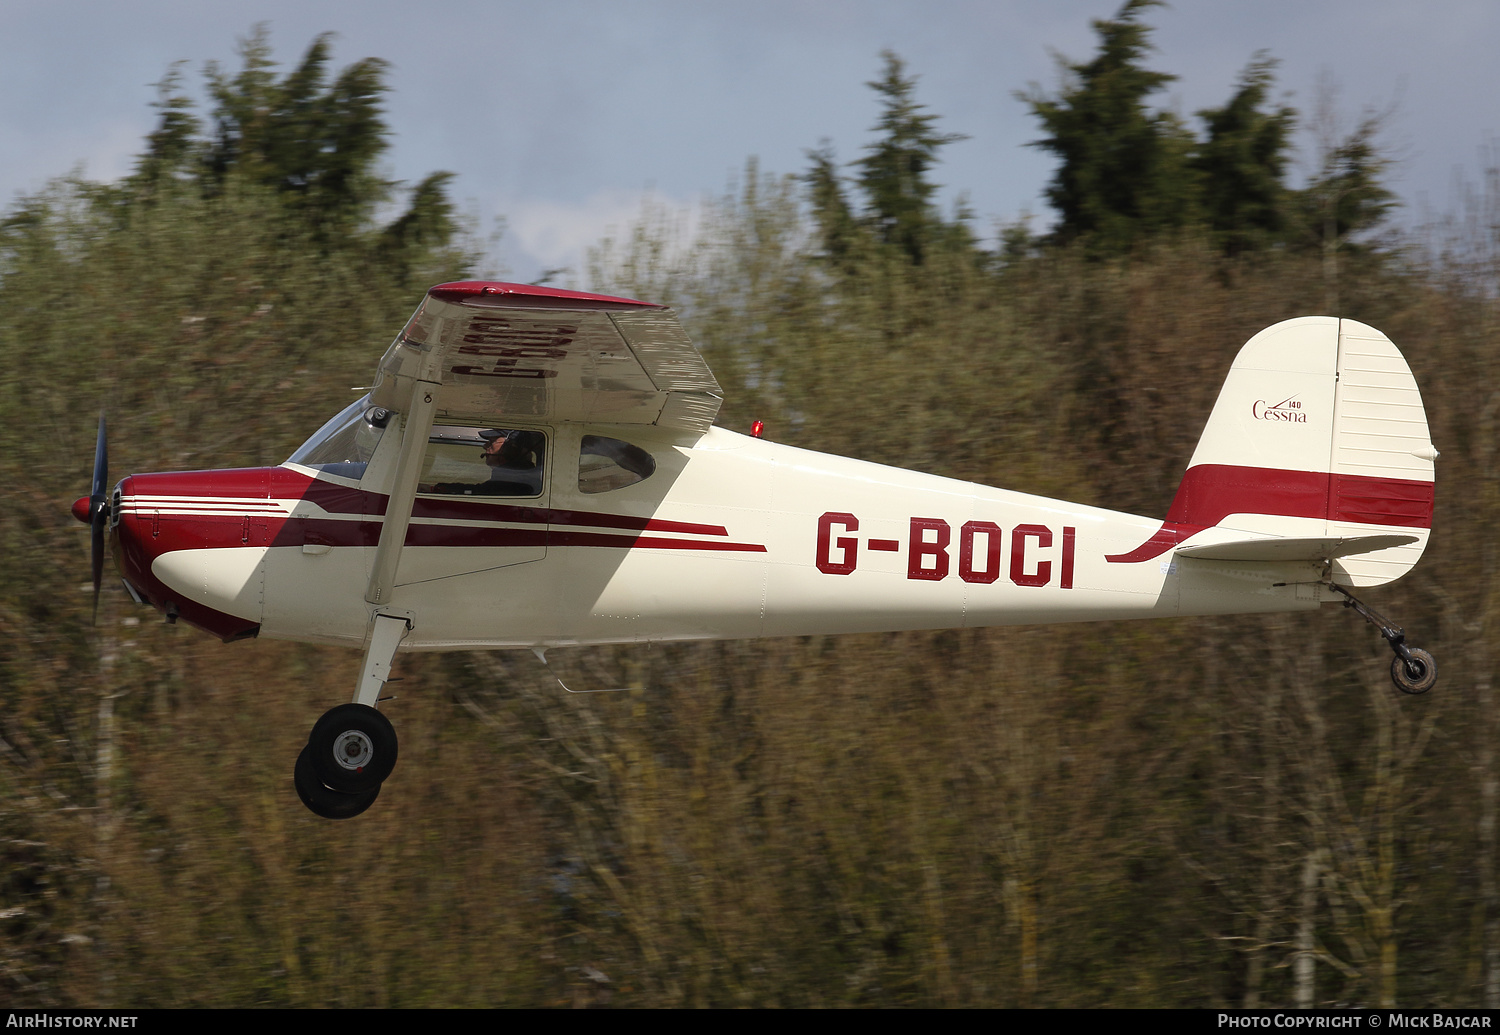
[417,425,548,497]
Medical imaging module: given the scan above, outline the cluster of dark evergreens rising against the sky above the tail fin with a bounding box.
[1017,0,1394,264]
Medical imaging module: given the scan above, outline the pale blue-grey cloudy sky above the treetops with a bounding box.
[0,0,1500,281]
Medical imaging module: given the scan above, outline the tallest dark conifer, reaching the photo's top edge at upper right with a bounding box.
[1017,0,1196,251]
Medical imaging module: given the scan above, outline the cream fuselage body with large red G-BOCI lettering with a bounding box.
[122,425,1331,650]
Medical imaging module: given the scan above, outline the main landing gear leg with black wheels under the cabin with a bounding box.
[294,614,411,819]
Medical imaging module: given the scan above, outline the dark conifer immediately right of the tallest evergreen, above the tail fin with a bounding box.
[1193,53,1296,255]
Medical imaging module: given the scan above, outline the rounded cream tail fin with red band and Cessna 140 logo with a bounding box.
[1109,317,1437,587]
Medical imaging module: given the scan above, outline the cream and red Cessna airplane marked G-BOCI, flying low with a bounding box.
[74,282,1437,819]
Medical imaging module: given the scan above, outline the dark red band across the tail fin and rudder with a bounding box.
[1104,464,1434,564]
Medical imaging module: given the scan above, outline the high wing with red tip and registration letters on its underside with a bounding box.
[372,281,723,434]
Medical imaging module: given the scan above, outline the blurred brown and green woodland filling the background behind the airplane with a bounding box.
[0,12,1500,1007]
